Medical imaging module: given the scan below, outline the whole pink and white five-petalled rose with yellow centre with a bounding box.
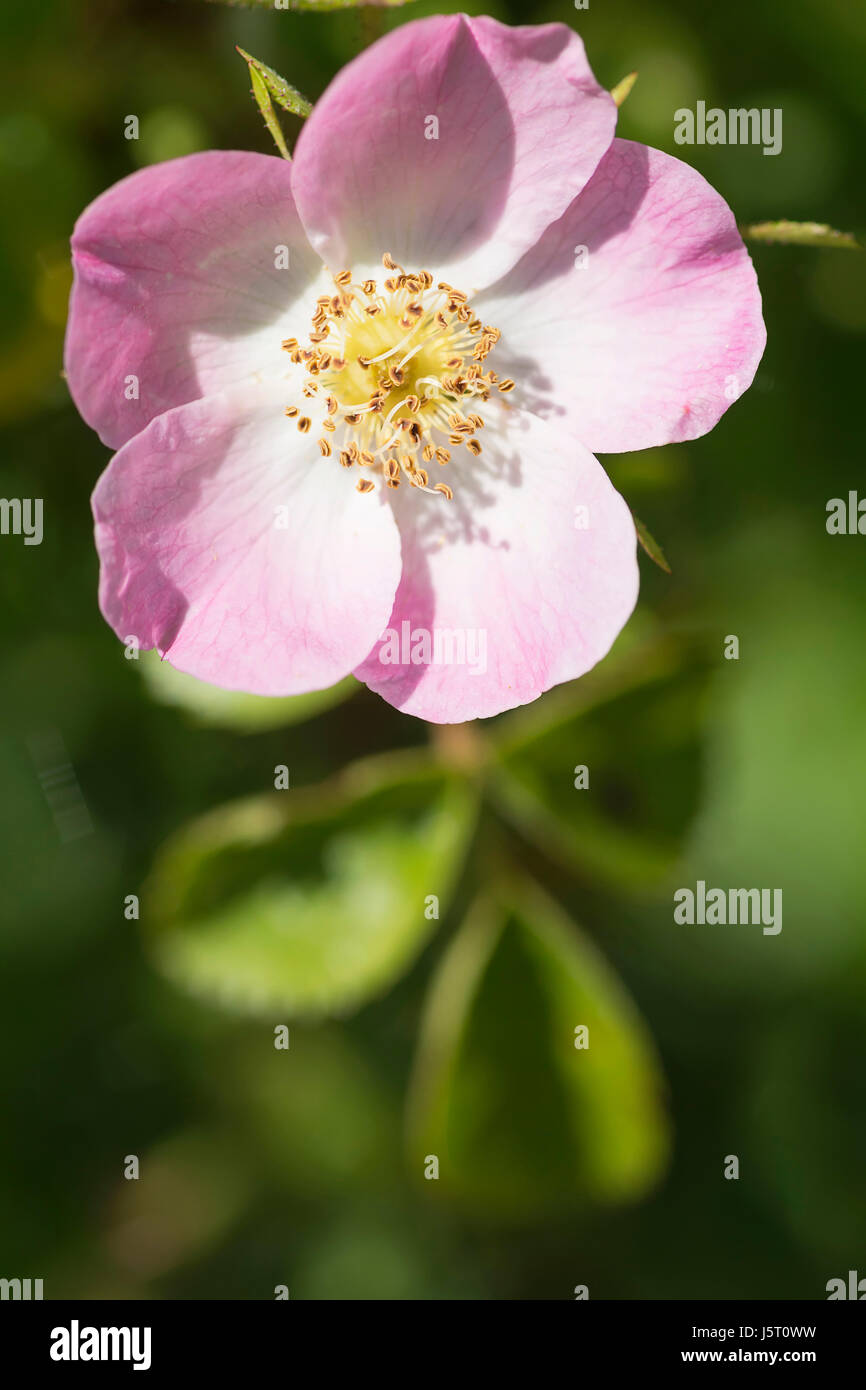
[65,15,765,723]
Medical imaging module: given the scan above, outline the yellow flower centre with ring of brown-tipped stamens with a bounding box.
[282,254,514,498]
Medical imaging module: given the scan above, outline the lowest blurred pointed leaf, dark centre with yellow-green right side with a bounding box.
[409,878,669,1216]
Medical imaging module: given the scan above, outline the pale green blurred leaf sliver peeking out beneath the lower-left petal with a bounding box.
[139,652,357,734]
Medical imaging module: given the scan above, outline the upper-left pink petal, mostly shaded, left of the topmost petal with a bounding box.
[65,150,322,448]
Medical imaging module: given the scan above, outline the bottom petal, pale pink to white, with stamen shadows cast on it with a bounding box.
[356,407,638,723]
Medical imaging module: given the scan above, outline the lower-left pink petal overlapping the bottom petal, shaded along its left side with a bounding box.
[93,385,400,695]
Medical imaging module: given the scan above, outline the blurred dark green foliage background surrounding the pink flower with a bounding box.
[0,0,866,1300]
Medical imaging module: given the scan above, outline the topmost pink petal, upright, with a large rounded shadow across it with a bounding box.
[293,14,616,292]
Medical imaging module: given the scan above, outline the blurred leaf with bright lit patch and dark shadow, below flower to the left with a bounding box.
[142,755,475,1017]
